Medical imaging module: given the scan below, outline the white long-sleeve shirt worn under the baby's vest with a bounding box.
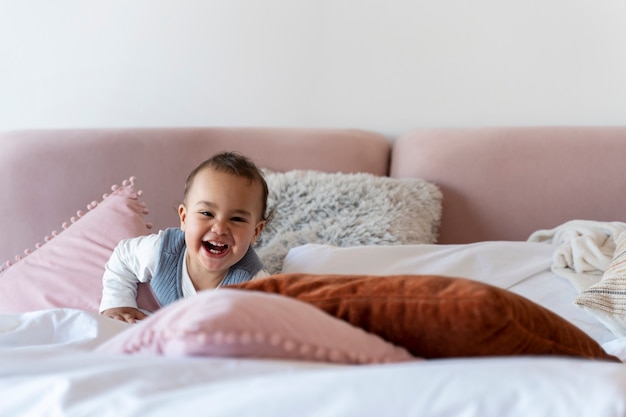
[100,230,269,312]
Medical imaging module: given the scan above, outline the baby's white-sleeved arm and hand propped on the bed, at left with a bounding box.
[100,233,160,323]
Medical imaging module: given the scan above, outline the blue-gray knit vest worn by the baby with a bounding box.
[150,228,263,307]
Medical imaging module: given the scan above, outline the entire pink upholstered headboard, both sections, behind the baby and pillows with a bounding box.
[0,127,626,259]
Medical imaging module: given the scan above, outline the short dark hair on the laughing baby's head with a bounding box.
[183,151,271,221]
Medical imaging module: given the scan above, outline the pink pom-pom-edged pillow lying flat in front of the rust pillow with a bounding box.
[97,288,418,364]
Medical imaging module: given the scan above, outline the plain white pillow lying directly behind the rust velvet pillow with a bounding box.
[283,241,615,343]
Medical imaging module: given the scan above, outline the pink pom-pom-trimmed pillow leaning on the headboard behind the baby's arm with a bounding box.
[0,177,150,313]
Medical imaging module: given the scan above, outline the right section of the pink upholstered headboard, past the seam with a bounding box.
[390,127,626,243]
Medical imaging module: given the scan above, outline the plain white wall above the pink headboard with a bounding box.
[0,0,626,136]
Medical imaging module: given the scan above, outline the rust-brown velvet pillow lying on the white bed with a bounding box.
[231,273,618,361]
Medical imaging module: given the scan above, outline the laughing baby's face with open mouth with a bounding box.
[179,169,265,282]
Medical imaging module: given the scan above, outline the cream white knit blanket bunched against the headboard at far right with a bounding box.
[528,220,626,293]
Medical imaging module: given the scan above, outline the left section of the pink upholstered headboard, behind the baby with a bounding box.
[0,128,390,263]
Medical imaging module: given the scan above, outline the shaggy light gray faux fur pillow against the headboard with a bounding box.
[255,170,442,273]
